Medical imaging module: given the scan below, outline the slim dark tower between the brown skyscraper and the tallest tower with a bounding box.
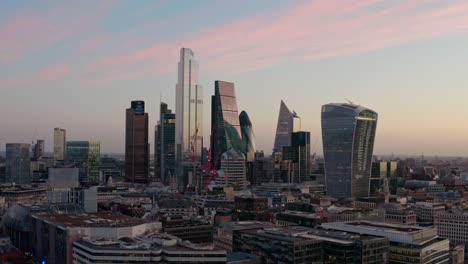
[154,103,176,185]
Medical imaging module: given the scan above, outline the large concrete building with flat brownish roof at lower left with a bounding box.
[31,212,161,264]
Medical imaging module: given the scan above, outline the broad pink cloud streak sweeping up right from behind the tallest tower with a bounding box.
[92,0,468,80]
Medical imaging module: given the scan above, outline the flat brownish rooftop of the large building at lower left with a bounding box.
[33,212,145,227]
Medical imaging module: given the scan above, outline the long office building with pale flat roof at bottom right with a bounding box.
[322,221,450,264]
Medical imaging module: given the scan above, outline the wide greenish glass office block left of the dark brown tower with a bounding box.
[66,141,101,186]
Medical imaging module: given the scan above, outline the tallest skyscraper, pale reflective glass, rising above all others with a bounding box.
[175,48,203,190]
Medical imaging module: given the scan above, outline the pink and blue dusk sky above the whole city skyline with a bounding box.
[0,0,468,156]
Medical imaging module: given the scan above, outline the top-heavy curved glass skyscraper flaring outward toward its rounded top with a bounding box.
[322,104,377,198]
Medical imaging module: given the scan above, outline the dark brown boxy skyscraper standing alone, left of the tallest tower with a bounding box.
[125,101,149,183]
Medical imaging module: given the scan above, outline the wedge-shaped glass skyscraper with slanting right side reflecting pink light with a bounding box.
[211,81,244,164]
